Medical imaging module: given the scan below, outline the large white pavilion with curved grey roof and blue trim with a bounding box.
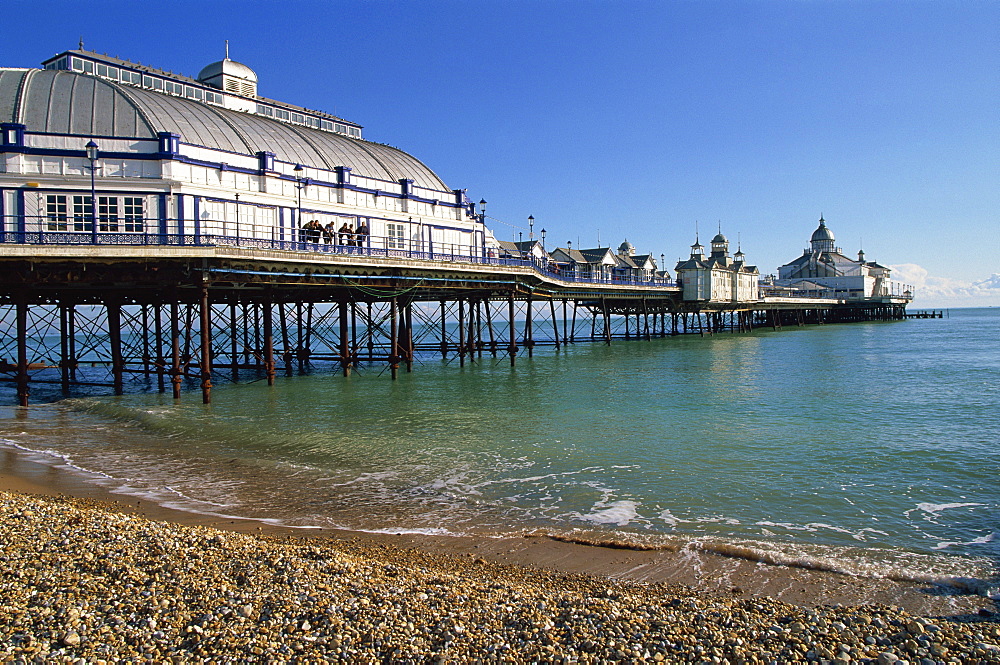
[0,50,488,254]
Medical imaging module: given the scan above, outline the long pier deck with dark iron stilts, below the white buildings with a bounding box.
[0,234,908,405]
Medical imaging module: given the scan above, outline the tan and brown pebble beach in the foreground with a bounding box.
[0,492,1000,665]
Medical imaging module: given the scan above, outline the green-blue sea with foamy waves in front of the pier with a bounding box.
[0,308,1000,595]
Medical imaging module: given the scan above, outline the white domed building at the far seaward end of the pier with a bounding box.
[774,215,892,300]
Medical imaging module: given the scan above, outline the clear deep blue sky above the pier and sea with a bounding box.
[7,0,1000,306]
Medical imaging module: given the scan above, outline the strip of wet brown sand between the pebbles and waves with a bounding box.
[0,450,997,616]
